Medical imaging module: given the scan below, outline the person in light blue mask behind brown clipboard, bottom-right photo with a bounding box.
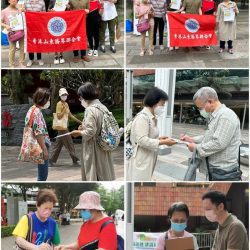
[155,202,199,250]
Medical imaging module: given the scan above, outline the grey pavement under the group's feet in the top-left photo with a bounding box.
[1,28,124,69]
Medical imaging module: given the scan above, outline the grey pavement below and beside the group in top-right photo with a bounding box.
[126,10,249,68]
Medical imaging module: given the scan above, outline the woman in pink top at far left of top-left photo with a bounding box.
[1,0,25,68]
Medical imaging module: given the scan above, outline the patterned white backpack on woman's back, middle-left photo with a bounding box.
[92,104,121,151]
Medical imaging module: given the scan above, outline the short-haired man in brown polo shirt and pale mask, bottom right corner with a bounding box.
[202,191,249,250]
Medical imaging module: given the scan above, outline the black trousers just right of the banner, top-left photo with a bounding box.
[87,10,101,50]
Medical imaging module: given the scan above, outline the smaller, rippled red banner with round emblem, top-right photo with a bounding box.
[166,13,218,47]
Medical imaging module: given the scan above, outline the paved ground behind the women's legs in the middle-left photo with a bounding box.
[1,144,124,182]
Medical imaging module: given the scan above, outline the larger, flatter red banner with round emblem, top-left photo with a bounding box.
[25,10,87,52]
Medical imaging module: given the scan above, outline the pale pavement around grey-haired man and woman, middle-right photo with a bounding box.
[152,123,249,181]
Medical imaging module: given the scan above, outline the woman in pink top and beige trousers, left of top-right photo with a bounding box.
[135,0,154,56]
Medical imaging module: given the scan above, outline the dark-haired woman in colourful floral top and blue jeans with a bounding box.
[19,88,51,181]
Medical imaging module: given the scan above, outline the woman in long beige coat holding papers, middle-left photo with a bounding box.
[71,82,115,181]
